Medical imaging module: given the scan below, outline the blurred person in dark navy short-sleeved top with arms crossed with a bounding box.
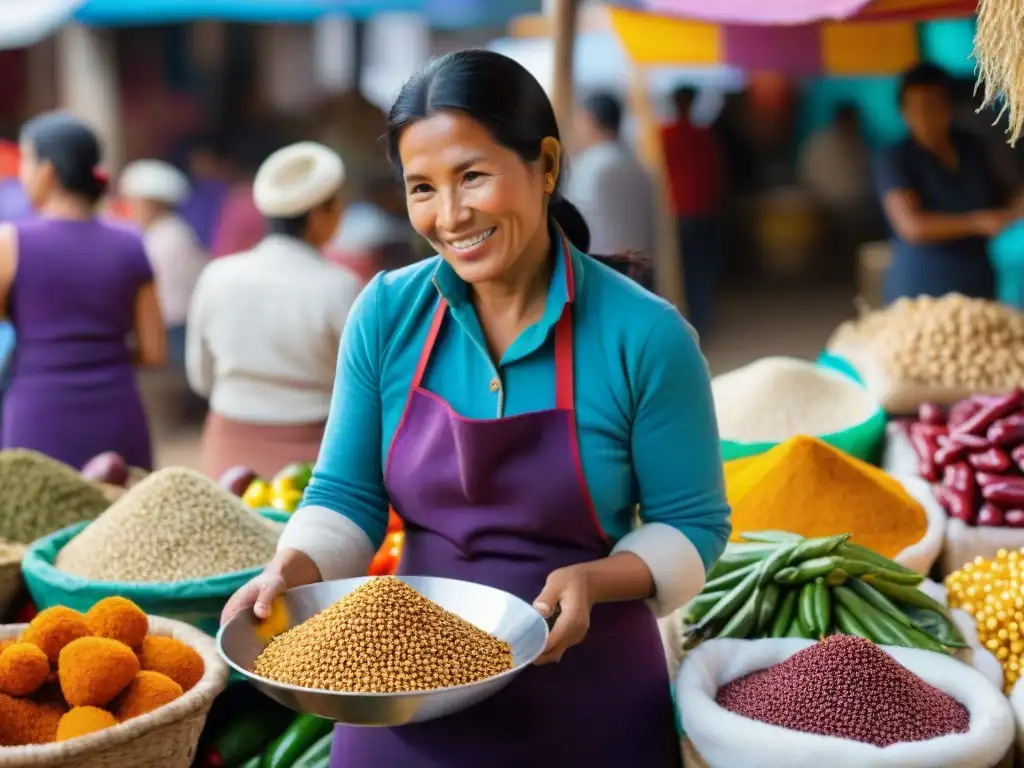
[874,63,1020,303]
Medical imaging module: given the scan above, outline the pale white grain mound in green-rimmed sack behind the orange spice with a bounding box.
[712,357,877,442]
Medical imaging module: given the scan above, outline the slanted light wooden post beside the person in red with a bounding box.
[630,67,686,312]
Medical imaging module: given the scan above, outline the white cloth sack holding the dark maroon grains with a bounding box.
[676,638,1015,768]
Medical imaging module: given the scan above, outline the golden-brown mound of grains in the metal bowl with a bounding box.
[253,577,512,693]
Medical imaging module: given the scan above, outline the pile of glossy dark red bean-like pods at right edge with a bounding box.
[907,389,1024,528]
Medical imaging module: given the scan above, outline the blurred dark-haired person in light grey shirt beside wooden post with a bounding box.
[565,92,655,258]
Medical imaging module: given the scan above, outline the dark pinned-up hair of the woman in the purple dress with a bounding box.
[20,112,108,205]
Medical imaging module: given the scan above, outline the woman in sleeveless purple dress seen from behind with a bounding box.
[0,113,167,469]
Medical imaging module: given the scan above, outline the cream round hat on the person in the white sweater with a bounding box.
[253,141,345,218]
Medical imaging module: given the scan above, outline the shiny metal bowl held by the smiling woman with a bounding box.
[217,577,548,727]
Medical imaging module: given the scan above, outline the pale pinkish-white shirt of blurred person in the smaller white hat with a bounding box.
[142,214,209,328]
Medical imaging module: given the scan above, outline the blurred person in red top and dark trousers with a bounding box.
[662,87,722,333]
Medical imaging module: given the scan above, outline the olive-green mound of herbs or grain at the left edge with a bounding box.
[0,449,110,544]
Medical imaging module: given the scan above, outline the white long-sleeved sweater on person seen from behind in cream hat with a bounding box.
[185,234,362,424]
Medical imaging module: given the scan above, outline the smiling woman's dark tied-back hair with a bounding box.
[387,50,590,251]
